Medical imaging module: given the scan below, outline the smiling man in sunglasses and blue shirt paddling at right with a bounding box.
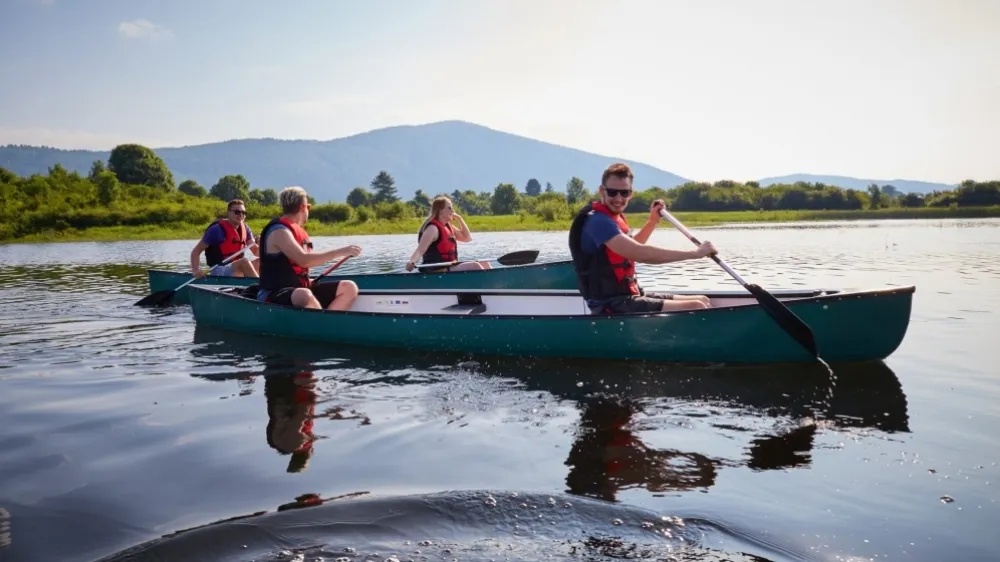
[569,163,715,314]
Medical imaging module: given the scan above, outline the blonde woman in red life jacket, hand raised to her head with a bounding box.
[406,195,492,273]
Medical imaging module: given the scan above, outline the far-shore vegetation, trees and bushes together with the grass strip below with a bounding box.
[0,144,1000,244]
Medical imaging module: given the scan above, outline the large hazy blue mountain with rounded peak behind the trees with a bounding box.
[0,121,688,202]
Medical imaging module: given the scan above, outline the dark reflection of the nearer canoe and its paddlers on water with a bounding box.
[193,327,909,501]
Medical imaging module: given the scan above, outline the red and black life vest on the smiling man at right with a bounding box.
[569,202,642,301]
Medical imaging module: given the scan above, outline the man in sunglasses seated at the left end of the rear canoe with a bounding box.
[191,199,260,279]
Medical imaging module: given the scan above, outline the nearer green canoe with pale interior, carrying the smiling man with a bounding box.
[188,285,915,363]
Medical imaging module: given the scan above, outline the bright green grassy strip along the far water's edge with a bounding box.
[6,206,1000,243]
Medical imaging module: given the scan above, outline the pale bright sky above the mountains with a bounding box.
[0,0,1000,183]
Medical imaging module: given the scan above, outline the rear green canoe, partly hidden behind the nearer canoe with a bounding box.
[147,260,577,304]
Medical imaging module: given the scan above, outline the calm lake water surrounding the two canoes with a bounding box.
[0,220,1000,561]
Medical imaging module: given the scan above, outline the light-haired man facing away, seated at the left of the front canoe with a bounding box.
[257,187,361,310]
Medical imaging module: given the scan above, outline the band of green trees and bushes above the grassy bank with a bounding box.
[0,140,1000,240]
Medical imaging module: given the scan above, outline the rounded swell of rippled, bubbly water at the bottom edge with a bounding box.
[95,491,796,562]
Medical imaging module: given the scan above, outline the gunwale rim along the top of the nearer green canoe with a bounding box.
[189,284,916,322]
